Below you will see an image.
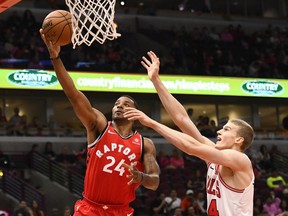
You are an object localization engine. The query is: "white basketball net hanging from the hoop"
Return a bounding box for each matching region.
[66,0,121,48]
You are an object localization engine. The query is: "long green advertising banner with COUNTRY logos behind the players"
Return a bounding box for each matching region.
[0,69,288,98]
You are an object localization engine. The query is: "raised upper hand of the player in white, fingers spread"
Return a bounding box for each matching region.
[141,51,160,80]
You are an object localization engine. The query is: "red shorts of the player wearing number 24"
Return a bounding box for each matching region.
[73,198,134,216]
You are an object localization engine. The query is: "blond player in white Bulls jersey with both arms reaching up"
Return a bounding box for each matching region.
[124,51,254,216]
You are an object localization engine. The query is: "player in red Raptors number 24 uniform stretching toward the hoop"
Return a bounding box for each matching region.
[40,29,159,216]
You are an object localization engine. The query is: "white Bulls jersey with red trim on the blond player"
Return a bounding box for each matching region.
[206,163,254,216]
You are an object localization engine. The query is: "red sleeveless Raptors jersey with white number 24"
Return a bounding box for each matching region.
[83,122,144,205]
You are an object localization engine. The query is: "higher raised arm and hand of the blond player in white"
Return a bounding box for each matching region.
[141,51,209,143]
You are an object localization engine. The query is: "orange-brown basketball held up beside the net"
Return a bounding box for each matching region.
[42,10,73,46]
